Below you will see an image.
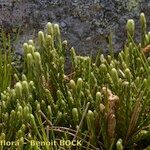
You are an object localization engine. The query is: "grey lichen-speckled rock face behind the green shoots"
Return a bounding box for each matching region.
[0,0,150,69]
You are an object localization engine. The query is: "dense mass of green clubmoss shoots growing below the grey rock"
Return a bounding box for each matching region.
[0,13,150,150]
